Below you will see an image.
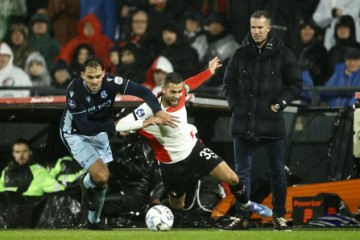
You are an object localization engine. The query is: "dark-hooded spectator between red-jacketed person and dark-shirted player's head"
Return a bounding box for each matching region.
[67,43,94,78]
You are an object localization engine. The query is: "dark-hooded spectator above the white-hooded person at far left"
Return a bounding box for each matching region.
[8,23,34,70]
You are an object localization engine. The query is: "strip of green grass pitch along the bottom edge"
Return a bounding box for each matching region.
[0,228,360,240]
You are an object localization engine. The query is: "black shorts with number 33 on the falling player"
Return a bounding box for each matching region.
[160,140,224,198]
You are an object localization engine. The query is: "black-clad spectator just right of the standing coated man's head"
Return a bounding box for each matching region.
[293,21,328,86]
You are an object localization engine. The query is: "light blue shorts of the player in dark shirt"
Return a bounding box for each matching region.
[61,132,113,170]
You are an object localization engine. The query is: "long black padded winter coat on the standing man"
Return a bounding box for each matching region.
[224,32,302,141]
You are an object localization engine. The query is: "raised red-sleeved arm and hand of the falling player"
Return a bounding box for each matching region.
[184,57,222,93]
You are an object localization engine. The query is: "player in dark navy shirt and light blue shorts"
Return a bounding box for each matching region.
[60,56,178,230]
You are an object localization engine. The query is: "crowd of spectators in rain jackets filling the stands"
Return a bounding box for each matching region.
[0,0,360,106]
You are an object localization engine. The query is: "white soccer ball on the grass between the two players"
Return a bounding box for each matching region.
[145,205,174,231]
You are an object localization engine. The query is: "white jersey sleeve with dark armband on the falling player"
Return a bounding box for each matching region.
[116,103,154,132]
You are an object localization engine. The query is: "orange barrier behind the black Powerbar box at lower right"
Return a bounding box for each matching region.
[251,179,360,222]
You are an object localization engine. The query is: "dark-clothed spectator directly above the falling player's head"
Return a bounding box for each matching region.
[160,22,199,78]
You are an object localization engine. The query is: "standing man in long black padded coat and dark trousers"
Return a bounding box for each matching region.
[224,11,302,230]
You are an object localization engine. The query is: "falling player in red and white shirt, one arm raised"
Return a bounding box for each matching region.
[116,57,272,225]
